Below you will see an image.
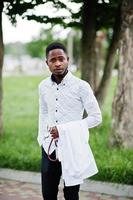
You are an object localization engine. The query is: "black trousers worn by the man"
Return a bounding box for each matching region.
[41,148,80,200]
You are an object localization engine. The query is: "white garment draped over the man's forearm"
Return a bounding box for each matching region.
[57,120,98,186]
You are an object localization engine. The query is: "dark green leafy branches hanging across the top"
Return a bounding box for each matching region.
[4,0,120,30]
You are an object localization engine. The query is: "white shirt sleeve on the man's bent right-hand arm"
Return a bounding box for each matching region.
[79,81,102,128]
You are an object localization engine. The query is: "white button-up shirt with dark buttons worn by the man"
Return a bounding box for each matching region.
[38,72,102,153]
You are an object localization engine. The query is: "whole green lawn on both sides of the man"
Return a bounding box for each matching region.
[0,74,133,184]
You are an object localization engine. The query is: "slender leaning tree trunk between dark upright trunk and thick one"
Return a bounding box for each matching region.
[95,5,120,106]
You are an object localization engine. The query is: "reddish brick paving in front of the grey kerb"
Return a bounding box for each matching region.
[0,179,133,200]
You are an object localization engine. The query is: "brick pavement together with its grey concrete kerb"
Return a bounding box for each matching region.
[0,168,133,200]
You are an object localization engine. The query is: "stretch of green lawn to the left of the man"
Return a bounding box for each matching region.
[0,77,43,171]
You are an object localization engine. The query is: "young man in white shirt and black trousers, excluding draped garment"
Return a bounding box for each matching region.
[38,42,102,200]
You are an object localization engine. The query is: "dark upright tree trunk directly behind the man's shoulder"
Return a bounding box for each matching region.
[81,0,96,90]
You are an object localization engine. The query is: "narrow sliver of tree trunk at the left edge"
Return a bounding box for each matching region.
[0,2,4,135]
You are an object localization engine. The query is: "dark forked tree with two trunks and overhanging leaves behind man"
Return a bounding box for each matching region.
[27,0,120,100]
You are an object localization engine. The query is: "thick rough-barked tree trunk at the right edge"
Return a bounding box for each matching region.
[110,0,133,148]
